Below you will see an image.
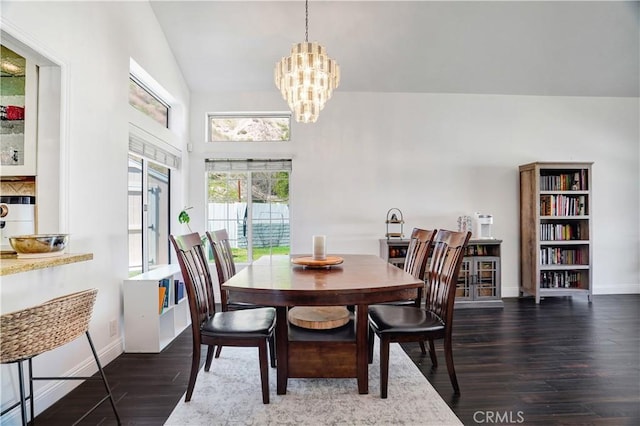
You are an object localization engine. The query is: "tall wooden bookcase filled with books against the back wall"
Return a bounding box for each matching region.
[519,162,593,303]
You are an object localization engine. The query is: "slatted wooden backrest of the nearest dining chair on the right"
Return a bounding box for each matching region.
[425,233,471,332]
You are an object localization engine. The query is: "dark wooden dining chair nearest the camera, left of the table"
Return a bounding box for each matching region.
[169,233,276,404]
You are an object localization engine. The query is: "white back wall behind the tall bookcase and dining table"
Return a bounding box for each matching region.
[190,89,640,297]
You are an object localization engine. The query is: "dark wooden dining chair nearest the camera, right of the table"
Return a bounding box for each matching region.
[369,229,471,398]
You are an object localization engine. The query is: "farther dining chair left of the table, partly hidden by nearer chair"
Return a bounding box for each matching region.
[205,229,276,368]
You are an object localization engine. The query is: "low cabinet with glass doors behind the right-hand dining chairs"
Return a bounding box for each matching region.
[379,238,503,308]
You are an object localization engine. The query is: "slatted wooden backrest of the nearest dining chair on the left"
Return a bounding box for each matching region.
[169,232,216,332]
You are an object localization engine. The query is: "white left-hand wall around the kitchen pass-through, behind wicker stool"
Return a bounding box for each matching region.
[1,1,189,424]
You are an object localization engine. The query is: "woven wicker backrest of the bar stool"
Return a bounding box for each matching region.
[0,289,98,364]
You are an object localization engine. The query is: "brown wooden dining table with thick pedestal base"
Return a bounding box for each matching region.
[222,254,424,395]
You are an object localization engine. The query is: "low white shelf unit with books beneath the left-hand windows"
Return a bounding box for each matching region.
[123,265,191,353]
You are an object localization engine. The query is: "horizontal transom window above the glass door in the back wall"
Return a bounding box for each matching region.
[207,112,291,142]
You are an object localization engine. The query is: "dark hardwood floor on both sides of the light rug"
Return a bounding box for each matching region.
[36,295,640,425]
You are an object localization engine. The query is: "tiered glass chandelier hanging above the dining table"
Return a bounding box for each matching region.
[274,0,340,123]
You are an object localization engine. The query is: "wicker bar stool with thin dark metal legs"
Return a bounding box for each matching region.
[0,289,121,425]
